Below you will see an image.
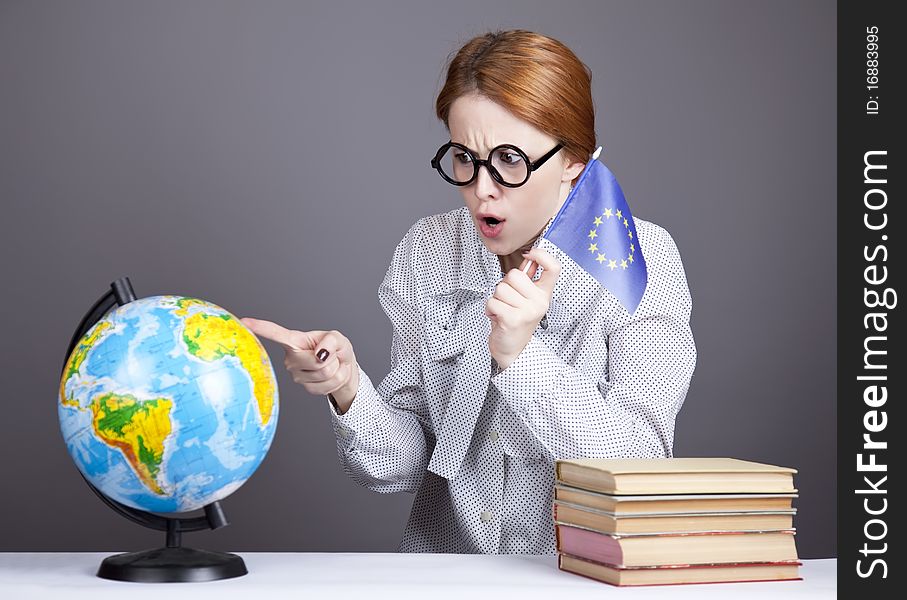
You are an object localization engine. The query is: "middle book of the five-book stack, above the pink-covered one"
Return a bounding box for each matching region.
[552,500,794,534]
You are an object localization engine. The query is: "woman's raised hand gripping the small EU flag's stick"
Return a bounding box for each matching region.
[485,248,561,369]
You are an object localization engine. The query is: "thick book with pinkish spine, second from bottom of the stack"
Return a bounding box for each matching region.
[555,523,798,567]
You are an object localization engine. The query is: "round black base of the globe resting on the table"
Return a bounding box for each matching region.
[98,547,248,583]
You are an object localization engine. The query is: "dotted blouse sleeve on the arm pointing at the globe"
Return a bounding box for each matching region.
[327,227,429,493]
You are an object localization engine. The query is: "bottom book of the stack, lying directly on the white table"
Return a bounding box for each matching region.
[558,554,803,586]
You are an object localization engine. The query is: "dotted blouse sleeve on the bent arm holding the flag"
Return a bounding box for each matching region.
[492,230,696,462]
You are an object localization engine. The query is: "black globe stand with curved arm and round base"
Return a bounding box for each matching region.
[63,277,248,583]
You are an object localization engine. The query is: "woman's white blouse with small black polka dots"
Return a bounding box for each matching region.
[326,207,696,554]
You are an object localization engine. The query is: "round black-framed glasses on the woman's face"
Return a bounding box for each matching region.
[431,142,564,188]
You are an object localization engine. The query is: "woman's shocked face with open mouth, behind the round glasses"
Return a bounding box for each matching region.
[447,93,584,256]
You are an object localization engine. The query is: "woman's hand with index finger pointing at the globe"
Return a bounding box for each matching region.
[240,317,359,413]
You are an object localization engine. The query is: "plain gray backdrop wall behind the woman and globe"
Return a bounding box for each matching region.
[0,0,836,558]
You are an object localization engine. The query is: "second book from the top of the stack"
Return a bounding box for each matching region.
[554,483,797,515]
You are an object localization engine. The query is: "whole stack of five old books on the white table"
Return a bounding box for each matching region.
[553,458,801,586]
